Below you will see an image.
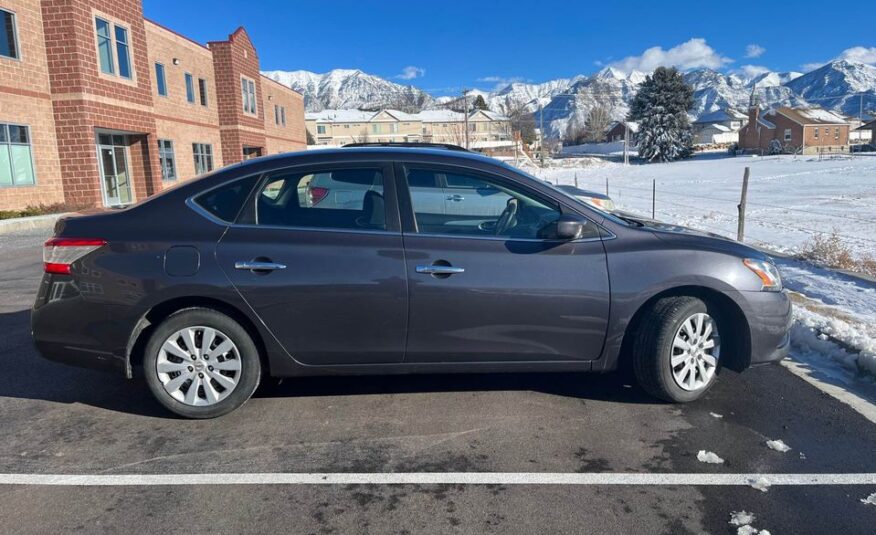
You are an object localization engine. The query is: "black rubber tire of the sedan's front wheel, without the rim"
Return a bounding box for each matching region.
[632,296,725,403]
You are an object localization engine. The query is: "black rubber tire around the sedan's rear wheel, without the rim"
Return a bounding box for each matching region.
[143,308,261,419]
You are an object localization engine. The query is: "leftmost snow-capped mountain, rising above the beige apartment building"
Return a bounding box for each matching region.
[262,69,433,111]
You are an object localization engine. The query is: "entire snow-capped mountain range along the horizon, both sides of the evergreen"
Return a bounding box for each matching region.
[263,60,876,137]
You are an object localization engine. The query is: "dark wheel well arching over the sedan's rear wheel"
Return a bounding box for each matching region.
[128,297,271,376]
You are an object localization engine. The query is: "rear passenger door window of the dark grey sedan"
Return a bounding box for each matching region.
[255,168,386,230]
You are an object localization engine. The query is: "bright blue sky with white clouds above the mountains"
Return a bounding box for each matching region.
[144,0,876,95]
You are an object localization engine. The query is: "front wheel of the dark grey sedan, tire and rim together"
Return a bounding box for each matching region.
[633,296,721,403]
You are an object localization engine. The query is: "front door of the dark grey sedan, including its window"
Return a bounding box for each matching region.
[399,164,609,362]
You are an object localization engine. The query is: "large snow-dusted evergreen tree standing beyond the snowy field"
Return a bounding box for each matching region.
[629,67,693,162]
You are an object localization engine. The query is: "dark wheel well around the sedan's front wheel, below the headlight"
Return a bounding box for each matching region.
[618,286,751,373]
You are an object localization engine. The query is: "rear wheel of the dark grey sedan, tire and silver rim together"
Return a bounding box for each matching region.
[143,308,261,418]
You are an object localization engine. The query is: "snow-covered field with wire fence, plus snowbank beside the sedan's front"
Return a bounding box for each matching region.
[526,154,876,402]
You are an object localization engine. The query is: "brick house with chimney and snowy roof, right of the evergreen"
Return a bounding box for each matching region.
[739,101,849,154]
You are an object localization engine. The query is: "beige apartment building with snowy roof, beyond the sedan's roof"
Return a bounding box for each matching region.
[305,110,514,149]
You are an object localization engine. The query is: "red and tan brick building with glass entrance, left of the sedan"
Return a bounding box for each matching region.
[0,0,306,209]
